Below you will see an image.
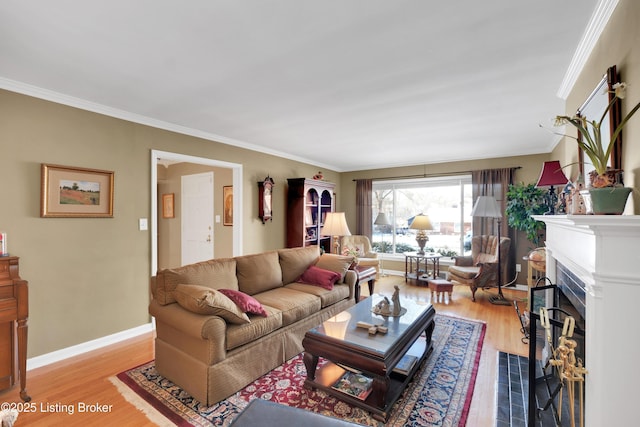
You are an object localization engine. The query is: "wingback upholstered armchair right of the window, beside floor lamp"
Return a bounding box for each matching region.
[448,235,511,301]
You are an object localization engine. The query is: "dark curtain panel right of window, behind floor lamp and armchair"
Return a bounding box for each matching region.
[471,168,516,284]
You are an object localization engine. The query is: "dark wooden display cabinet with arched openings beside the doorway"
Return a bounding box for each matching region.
[287,178,335,252]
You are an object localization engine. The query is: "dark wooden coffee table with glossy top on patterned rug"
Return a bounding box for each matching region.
[302,295,436,422]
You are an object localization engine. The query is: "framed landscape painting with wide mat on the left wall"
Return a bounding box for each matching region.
[40,163,113,218]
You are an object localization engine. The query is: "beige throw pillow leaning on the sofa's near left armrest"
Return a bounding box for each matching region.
[173,284,250,324]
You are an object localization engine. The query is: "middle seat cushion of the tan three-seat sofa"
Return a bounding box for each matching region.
[254,287,322,326]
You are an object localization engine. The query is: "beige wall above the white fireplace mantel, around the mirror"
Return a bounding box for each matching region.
[552,0,640,215]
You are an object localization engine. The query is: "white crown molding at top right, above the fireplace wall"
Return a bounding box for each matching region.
[557,0,619,100]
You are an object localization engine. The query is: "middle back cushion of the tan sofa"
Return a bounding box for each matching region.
[236,251,282,295]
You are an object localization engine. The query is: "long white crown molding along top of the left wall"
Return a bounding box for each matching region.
[0,77,343,172]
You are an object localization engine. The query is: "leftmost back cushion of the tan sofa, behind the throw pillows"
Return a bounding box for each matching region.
[154,258,238,305]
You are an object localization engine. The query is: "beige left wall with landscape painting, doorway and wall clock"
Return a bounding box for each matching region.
[0,90,339,357]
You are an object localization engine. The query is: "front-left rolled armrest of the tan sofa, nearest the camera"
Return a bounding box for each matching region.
[149,300,227,343]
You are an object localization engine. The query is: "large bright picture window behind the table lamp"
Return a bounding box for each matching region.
[371,175,473,256]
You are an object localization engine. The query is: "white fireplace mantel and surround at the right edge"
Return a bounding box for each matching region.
[534,215,640,426]
